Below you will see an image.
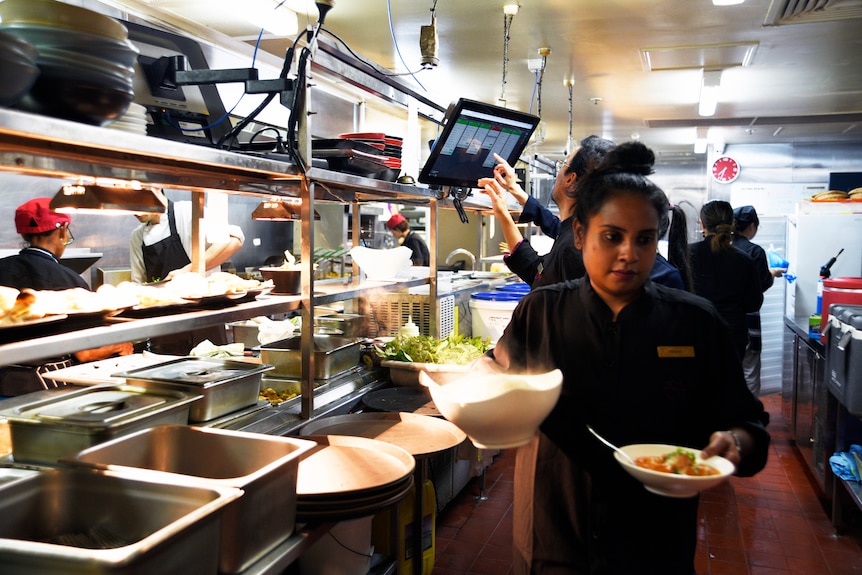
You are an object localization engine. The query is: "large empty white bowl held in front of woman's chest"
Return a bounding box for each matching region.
[419,369,563,449]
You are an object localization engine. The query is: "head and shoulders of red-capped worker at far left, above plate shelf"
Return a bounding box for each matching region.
[0,198,89,290]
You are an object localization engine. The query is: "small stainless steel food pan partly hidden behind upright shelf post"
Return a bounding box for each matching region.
[260,335,359,379]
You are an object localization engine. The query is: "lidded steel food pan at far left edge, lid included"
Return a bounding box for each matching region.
[0,384,200,464]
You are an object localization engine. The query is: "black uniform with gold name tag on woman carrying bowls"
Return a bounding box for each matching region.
[493,277,769,575]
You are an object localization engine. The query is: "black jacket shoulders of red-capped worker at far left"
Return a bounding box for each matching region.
[0,247,90,290]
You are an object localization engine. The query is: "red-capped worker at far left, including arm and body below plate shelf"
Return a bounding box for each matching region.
[0,198,133,397]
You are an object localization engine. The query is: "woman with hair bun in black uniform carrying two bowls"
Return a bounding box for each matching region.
[484,142,769,575]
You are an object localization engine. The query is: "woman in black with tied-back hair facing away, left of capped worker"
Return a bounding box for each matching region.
[690,200,763,359]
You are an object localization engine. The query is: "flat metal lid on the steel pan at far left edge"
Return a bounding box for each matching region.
[0,384,201,428]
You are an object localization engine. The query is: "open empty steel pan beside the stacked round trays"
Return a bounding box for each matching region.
[62,425,316,573]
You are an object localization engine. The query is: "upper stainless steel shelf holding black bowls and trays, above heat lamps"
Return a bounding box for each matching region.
[0,109,435,202]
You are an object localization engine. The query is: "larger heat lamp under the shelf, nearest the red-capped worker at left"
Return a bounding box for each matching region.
[49,178,167,215]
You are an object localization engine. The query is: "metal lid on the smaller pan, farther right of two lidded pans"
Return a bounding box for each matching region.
[111,357,273,387]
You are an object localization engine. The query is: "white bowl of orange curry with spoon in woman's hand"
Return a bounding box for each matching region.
[614,443,736,497]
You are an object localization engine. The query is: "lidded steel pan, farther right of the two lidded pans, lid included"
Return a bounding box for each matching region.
[111,357,272,422]
